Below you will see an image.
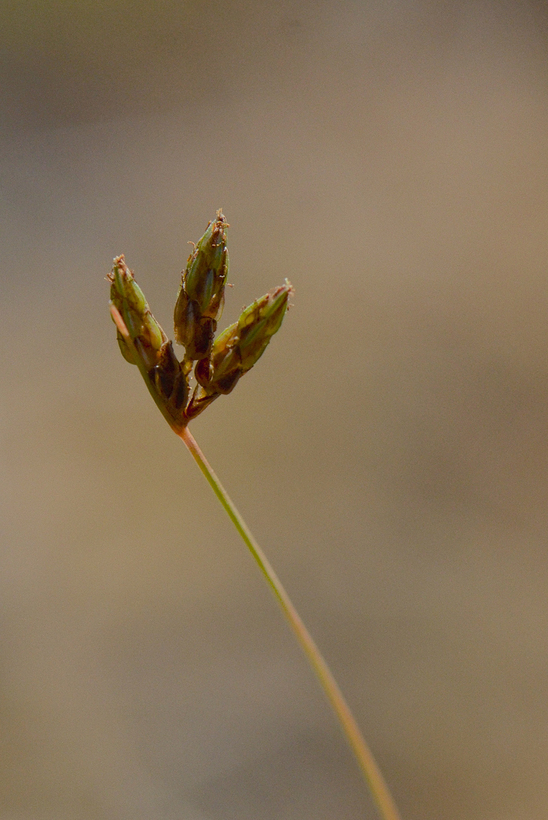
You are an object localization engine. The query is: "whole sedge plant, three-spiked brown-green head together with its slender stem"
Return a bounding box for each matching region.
[107,211,400,820]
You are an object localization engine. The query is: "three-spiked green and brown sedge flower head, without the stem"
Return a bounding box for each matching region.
[107,211,293,430]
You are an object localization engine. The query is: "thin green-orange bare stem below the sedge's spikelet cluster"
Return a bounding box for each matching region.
[180,427,401,820]
